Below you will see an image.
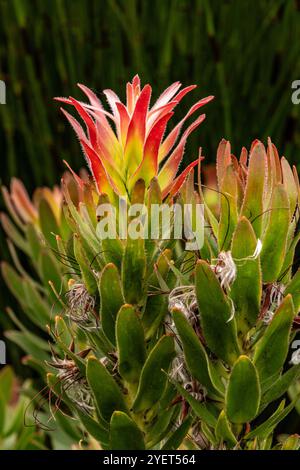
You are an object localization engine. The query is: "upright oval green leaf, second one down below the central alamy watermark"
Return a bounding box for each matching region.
[116,305,146,383]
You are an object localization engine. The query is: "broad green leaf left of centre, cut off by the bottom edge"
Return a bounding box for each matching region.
[110,411,145,450]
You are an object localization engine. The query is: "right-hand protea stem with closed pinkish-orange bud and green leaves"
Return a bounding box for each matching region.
[169,139,300,449]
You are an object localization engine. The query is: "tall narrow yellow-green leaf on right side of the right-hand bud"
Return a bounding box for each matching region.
[260,184,290,282]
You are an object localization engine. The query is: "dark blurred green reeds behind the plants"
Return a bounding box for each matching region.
[0,0,300,195]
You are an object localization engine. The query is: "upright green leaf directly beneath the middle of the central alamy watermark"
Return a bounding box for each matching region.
[122,237,146,304]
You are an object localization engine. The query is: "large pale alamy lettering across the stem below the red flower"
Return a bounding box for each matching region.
[97,197,205,251]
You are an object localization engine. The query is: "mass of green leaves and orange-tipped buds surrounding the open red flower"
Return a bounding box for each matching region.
[0,67,299,450]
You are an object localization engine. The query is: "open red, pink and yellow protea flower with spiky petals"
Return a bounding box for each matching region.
[56,75,213,198]
